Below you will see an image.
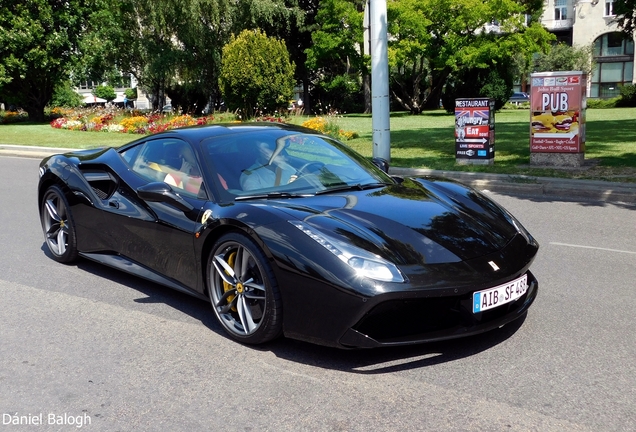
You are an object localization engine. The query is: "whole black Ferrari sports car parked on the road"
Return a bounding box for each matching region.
[38,123,539,348]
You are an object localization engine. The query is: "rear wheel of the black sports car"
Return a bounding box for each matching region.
[40,186,77,263]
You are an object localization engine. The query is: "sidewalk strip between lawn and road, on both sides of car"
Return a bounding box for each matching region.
[0,144,636,204]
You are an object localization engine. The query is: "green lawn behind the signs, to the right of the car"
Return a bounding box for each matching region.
[330,108,636,181]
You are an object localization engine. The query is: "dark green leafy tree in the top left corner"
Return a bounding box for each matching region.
[0,0,97,121]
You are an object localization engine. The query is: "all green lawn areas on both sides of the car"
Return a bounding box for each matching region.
[0,108,636,181]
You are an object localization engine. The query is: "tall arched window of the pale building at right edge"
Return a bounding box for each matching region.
[590,32,634,98]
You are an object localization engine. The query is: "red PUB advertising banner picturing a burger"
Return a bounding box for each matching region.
[530,72,587,153]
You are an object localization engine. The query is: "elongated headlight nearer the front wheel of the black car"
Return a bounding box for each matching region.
[289,221,404,282]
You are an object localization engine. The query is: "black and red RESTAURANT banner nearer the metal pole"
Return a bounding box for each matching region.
[455,98,495,164]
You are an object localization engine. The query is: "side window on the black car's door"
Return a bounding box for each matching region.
[128,138,206,198]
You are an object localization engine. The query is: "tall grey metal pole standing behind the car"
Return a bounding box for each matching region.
[368,0,391,161]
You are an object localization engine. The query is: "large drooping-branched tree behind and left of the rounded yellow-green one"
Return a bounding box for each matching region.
[91,0,303,113]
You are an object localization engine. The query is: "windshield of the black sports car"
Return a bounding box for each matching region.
[202,129,393,199]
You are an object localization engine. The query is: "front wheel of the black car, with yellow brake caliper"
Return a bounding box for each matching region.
[207,233,282,344]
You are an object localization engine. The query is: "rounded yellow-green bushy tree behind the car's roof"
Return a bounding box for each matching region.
[219,30,295,118]
